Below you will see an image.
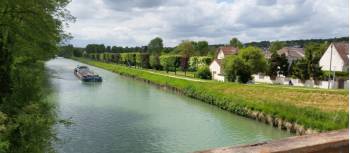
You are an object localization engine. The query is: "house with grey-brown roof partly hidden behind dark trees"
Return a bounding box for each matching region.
[277,47,305,66]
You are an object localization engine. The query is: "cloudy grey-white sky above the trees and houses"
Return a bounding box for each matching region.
[66,0,349,47]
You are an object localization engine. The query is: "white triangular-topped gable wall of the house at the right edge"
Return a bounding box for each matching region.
[319,44,346,71]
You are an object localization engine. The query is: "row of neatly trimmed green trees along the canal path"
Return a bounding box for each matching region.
[84,53,212,79]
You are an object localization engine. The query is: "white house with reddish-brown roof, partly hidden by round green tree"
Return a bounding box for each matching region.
[209,46,239,81]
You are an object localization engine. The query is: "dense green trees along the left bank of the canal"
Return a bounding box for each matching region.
[0,0,74,153]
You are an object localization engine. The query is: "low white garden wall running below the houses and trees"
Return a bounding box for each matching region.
[253,74,349,89]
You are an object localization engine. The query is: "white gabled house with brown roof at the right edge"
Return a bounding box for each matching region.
[319,42,349,71]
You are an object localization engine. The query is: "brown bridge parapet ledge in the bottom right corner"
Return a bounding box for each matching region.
[196,129,349,153]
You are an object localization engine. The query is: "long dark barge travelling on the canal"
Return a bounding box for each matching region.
[74,66,102,82]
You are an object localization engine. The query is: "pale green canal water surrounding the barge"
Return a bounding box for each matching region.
[46,58,290,153]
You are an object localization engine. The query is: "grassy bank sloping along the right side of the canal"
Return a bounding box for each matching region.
[75,58,348,131]
